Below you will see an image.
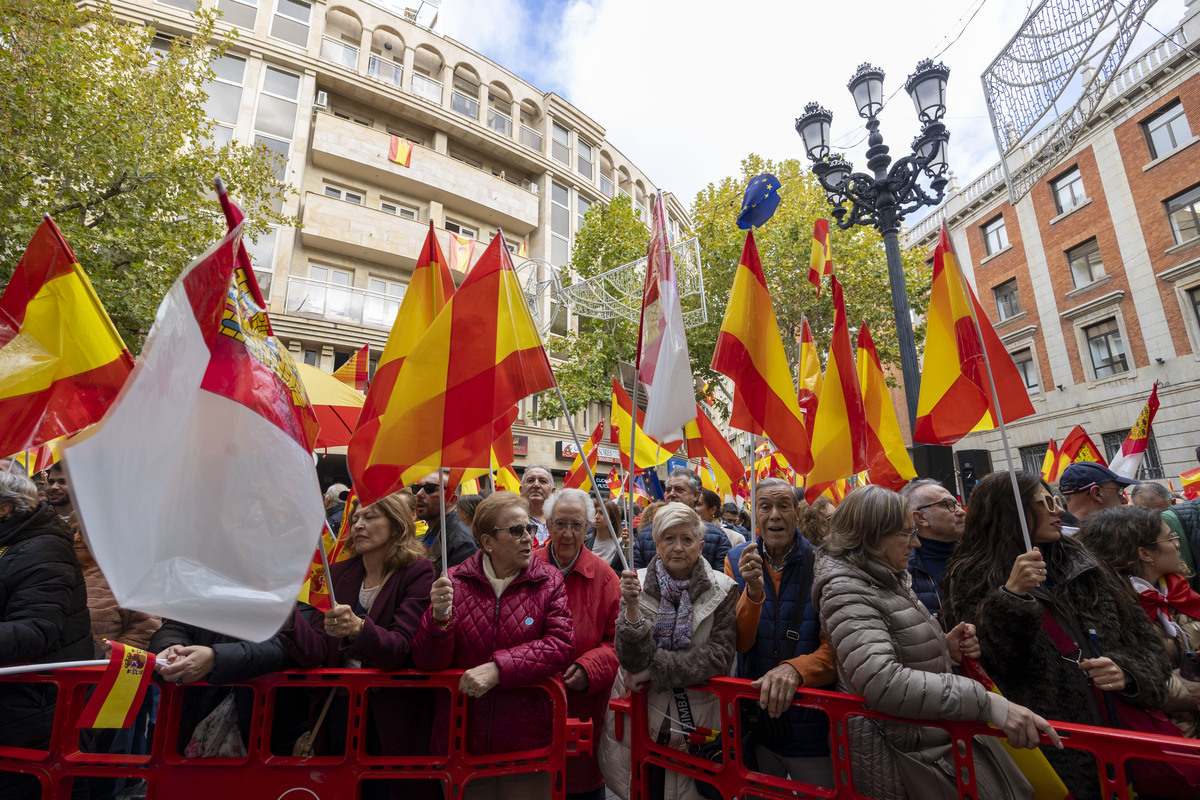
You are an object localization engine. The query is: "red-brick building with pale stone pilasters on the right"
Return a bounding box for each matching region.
[906,4,1200,488]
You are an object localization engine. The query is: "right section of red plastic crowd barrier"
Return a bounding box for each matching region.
[611,678,1200,800]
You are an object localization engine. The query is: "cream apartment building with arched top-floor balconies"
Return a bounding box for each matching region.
[120,0,690,479]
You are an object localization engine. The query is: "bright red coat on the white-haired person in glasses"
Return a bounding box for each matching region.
[534,545,620,793]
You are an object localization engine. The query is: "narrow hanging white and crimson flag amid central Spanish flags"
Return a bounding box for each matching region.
[637,192,696,441]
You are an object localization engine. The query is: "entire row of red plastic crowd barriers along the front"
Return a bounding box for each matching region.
[7,667,1200,800]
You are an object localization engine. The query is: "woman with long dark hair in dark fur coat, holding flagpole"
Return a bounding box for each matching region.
[942,471,1171,800]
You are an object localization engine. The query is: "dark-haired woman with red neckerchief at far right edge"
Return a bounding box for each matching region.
[1075,506,1200,739]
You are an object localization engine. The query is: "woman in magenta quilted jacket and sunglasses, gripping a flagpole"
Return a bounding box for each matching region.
[413,492,575,800]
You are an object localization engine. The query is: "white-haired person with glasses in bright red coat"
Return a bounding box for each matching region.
[533,489,620,800]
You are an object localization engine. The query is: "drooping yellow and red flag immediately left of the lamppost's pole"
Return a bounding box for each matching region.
[858,323,917,492]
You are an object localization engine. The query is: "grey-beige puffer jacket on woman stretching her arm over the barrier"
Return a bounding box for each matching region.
[812,553,1008,800]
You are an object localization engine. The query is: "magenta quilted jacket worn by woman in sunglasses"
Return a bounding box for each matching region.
[413,552,575,754]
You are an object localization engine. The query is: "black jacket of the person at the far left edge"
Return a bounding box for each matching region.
[0,503,96,747]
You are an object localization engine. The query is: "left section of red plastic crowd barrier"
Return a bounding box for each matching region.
[0,667,592,800]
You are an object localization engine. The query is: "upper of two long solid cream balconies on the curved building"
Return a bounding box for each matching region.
[305,112,538,232]
